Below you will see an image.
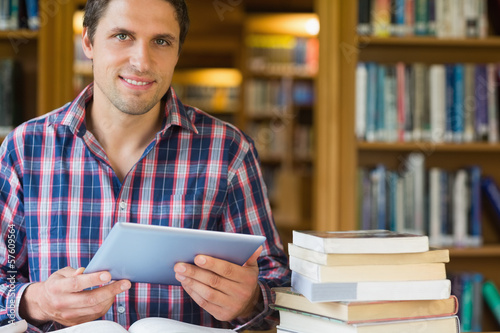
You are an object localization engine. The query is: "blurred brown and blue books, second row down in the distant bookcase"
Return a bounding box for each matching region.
[245,77,314,117]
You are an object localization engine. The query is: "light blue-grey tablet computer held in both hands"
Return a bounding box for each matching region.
[84,222,265,285]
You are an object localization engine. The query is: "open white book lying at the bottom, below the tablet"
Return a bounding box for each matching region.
[56,318,235,333]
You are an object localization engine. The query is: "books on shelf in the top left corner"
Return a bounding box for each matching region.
[0,0,40,30]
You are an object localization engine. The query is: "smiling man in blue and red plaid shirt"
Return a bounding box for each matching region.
[0,0,289,331]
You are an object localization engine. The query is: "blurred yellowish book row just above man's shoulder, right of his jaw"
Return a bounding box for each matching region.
[172,83,240,113]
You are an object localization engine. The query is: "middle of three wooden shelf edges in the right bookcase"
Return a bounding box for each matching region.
[357,142,500,153]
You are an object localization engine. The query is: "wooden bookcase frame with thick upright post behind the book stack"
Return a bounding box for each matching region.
[313,0,500,331]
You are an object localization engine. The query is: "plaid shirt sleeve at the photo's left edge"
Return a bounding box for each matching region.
[0,136,29,326]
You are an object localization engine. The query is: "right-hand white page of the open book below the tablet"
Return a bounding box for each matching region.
[129,318,235,333]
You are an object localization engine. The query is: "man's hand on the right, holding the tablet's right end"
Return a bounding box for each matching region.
[174,246,262,321]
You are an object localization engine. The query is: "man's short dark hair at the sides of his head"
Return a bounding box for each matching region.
[83,0,189,53]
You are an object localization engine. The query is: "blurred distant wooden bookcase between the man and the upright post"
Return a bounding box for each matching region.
[241,13,317,243]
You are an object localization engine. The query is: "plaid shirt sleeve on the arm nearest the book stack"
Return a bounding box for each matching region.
[225,136,290,330]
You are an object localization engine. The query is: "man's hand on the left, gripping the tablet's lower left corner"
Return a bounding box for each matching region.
[19,267,131,326]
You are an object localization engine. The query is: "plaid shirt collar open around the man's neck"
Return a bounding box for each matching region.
[51,83,198,136]
